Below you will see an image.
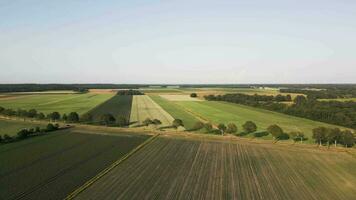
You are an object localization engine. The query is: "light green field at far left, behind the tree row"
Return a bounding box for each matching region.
[0,93,113,114]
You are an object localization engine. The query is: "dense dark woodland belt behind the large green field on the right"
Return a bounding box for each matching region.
[205,94,356,128]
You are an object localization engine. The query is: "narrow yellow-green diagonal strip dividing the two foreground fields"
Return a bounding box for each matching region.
[65,133,160,200]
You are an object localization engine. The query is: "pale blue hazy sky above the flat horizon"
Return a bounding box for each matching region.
[0,0,356,84]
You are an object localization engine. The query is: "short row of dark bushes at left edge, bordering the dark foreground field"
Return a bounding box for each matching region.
[0,123,59,143]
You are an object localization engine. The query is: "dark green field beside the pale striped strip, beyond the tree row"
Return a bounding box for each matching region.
[89,95,132,120]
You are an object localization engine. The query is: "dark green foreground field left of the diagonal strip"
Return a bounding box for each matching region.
[0,130,148,200]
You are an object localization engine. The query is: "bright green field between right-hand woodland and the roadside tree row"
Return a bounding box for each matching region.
[177,101,348,142]
